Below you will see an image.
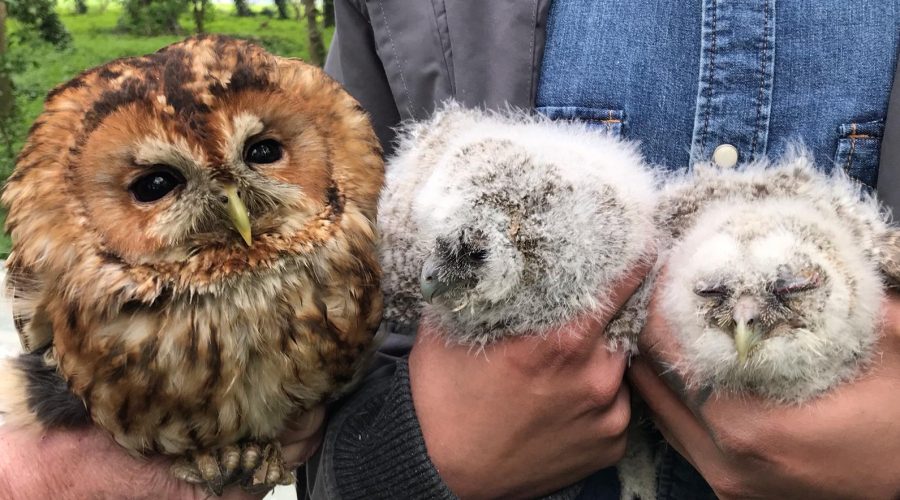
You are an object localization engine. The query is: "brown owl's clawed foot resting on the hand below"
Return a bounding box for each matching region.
[171,441,294,495]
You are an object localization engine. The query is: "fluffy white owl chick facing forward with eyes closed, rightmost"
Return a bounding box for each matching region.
[659,152,900,403]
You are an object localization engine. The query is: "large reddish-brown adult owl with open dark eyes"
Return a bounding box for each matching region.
[0,37,383,493]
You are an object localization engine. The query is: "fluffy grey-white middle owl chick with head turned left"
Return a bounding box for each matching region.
[379,105,656,346]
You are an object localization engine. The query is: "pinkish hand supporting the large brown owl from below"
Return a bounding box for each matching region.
[0,407,325,500]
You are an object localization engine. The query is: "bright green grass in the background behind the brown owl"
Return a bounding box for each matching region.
[0,2,334,256]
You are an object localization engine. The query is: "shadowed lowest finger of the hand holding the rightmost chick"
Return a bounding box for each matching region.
[627,359,719,463]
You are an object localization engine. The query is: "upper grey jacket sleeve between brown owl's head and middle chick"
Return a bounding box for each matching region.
[325,0,400,155]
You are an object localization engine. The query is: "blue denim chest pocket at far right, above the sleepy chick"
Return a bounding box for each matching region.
[834,120,884,188]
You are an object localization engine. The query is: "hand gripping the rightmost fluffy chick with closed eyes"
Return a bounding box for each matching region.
[628,286,900,498]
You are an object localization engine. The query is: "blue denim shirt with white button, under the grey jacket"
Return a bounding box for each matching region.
[536,0,900,186]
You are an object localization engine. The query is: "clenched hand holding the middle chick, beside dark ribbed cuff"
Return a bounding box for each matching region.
[409,268,647,498]
